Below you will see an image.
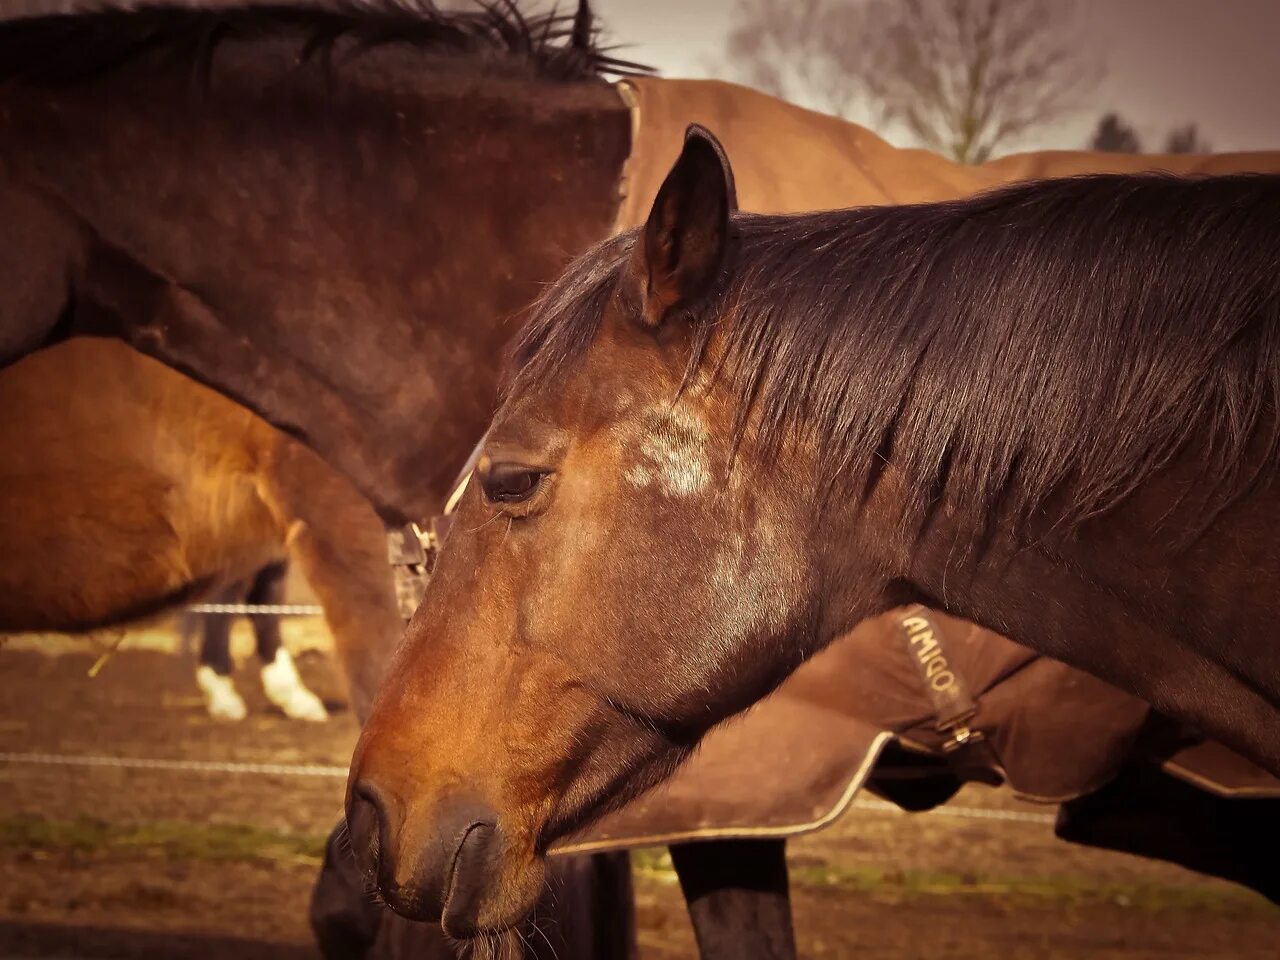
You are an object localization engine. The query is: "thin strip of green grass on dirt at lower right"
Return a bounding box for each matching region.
[631,847,1275,914]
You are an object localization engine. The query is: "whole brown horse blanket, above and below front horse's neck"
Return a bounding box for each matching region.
[559,79,1280,851]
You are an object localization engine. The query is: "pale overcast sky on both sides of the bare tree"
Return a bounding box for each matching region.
[593,0,1280,151]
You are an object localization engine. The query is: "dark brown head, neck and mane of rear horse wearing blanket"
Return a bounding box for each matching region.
[0,3,630,521]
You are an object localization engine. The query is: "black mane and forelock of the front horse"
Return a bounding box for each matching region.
[515,174,1280,527]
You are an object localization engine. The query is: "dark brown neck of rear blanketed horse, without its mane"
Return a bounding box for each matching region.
[0,58,628,521]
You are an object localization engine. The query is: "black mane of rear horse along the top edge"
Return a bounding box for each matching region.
[0,0,646,83]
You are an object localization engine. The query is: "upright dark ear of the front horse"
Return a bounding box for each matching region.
[625,123,737,328]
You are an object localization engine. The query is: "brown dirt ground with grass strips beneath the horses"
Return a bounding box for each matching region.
[0,625,1280,960]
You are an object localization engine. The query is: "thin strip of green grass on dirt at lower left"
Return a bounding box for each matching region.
[0,814,326,863]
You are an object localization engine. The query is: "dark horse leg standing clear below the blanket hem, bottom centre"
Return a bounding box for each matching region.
[671,840,796,960]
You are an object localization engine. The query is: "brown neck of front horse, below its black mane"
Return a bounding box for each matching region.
[822,448,1280,772]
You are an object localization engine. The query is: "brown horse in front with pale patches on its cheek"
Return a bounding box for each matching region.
[348,128,1280,934]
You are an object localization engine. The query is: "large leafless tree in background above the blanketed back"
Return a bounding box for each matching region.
[727,0,1096,163]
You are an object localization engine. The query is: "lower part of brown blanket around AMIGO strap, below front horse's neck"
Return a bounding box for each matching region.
[559,611,1280,851]
